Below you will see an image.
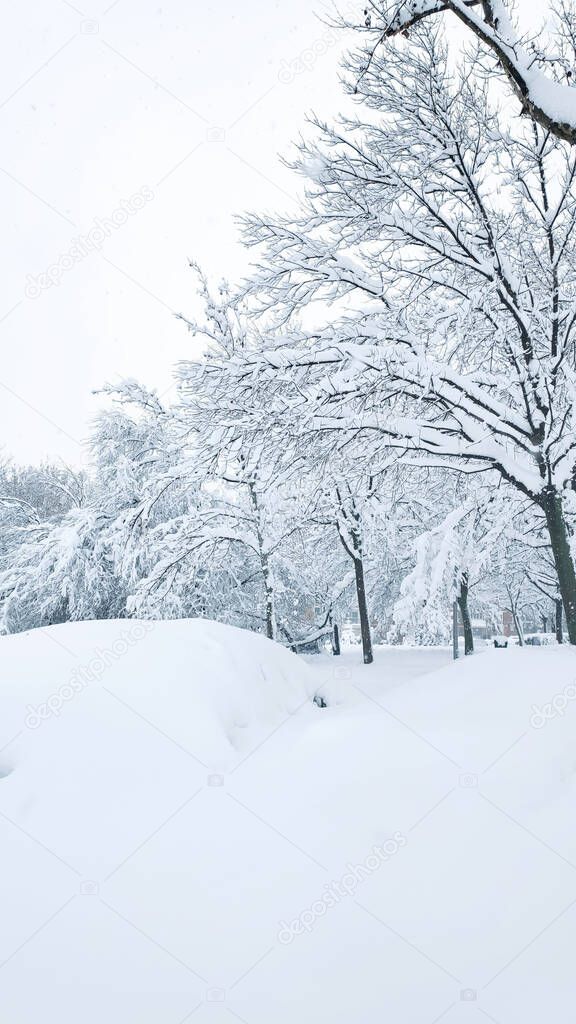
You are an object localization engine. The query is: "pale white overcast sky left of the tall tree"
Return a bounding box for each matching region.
[0,0,344,464]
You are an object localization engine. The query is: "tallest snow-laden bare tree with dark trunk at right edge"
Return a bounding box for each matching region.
[219,22,576,643]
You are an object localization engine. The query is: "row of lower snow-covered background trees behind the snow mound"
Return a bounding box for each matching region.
[0,446,563,664]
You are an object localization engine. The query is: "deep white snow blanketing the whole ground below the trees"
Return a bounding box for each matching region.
[0,622,576,1024]
